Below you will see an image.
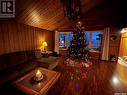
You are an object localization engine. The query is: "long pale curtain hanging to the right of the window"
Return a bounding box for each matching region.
[101,27,110,60]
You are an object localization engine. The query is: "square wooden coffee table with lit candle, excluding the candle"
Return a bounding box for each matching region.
[12,68,60,95]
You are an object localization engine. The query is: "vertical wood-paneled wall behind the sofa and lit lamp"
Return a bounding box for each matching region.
[0,21,54,54]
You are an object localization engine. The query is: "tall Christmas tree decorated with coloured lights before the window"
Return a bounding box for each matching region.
[68,22,89,63]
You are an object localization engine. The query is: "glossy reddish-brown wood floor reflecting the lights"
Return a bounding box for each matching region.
[48,60,127,95]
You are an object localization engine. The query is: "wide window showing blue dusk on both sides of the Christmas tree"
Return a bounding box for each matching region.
[58,31,103,50]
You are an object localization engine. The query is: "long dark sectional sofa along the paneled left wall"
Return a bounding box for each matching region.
[0,50,58,87]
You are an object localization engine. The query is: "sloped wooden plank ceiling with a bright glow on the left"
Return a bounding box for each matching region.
[15,0,126,31]
